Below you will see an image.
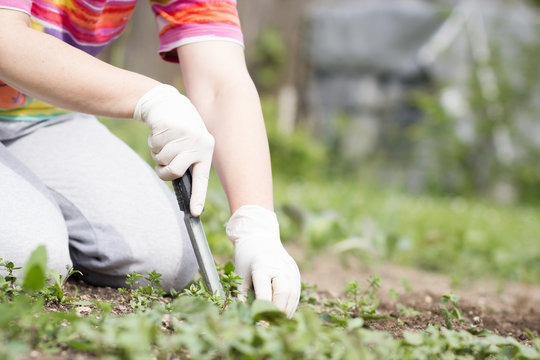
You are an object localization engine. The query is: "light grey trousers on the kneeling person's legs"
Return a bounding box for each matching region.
[0,113,197,290]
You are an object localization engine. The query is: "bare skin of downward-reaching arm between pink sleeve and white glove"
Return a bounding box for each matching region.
[178,41,273,213]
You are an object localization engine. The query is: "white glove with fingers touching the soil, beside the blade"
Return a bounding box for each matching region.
[226,205,301,317]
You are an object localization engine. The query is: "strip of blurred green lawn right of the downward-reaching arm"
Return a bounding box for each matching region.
[276,177,540,283]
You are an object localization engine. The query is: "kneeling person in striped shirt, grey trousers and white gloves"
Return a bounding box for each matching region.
[0,0,300,316]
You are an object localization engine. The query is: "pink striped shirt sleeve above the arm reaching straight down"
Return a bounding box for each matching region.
[146,0,244,62]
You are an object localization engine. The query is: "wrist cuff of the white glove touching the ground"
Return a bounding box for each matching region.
[225,205,281,245]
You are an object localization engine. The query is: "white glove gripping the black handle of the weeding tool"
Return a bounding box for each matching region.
[133,84,214,216]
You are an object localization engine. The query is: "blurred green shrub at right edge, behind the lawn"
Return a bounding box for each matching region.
[411,25,540,201]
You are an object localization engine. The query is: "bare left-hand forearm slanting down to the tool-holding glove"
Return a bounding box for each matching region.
[0,9,159,118]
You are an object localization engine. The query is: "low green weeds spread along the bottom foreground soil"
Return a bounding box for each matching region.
[0,250,540,360]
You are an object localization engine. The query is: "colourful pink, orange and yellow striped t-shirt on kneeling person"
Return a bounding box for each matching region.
[0,0,243,121]
